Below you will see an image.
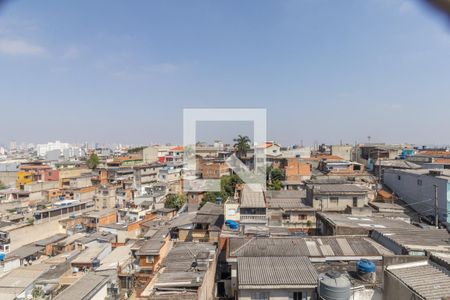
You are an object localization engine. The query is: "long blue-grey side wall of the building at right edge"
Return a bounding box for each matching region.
[384,169,450,222]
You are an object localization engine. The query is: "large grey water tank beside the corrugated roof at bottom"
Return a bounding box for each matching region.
[318,271,351,300]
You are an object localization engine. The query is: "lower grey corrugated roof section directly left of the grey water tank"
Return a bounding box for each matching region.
[237,256,318,290]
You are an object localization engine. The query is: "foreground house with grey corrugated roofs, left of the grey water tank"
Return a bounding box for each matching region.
[222,236,392,300]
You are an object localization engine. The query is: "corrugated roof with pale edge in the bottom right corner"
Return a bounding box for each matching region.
[387,261,450,300]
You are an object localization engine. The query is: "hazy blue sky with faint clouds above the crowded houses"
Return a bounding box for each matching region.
[0,0,450,144]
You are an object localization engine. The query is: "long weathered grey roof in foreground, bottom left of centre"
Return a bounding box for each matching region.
[139,242,217,300]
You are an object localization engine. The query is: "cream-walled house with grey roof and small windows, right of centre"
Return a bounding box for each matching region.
[306,183,369,211]
